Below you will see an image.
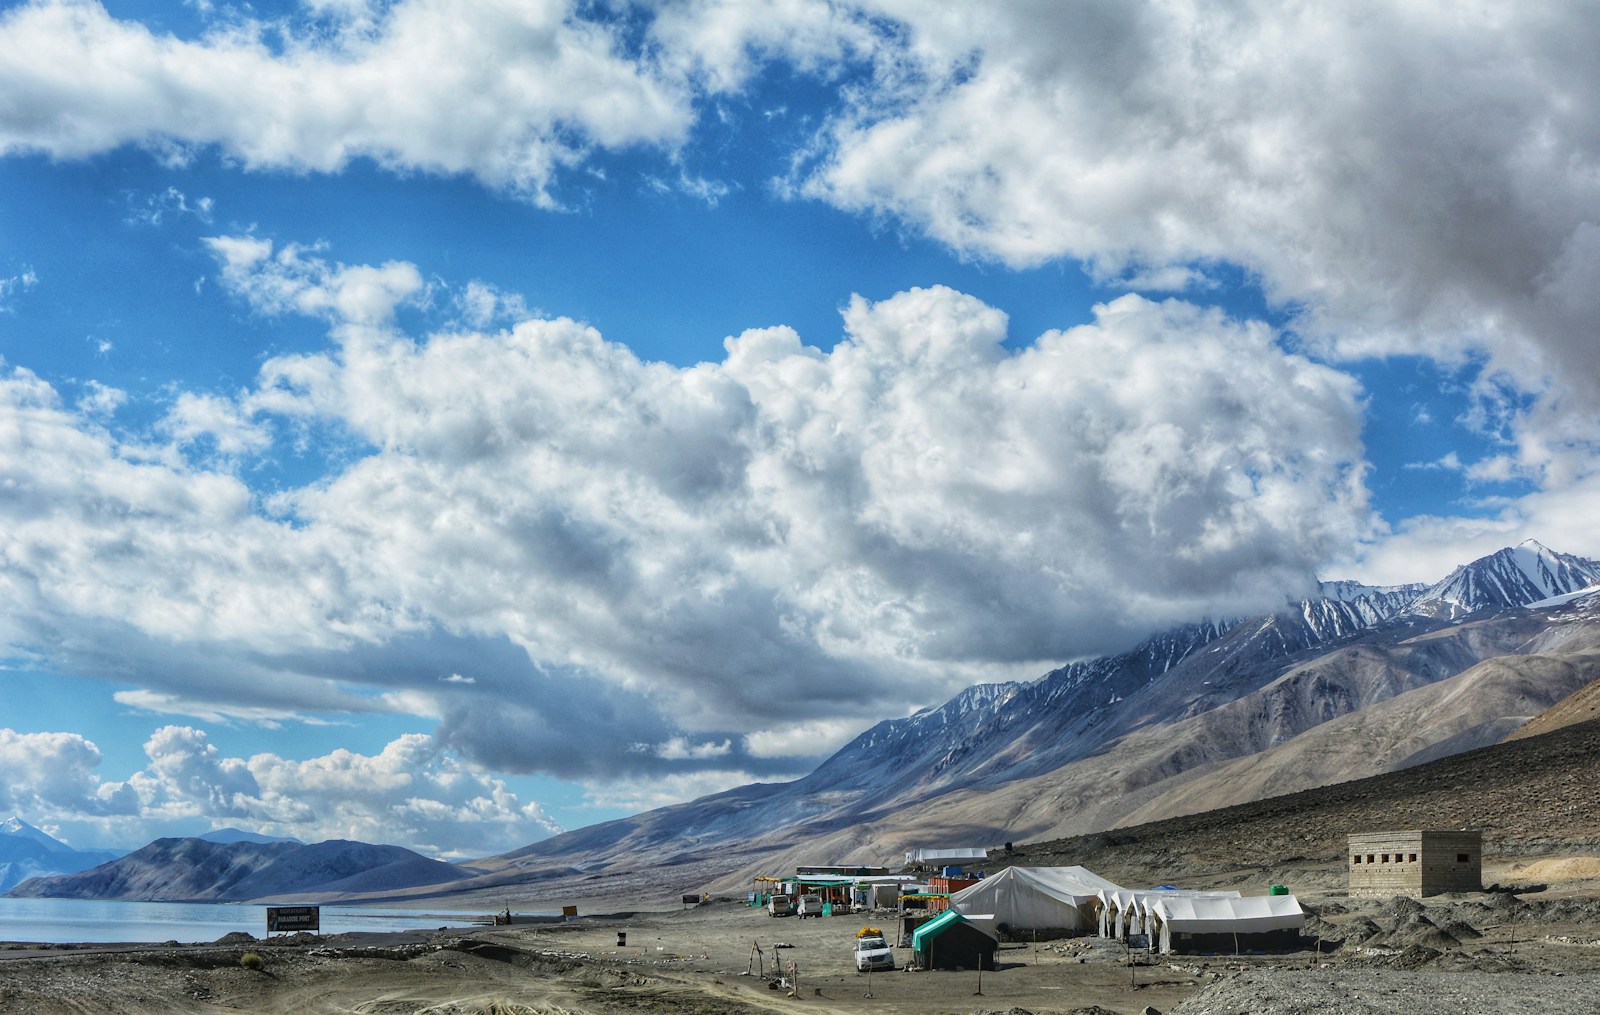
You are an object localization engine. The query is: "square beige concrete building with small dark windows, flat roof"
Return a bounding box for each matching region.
[1346,831,1483,898]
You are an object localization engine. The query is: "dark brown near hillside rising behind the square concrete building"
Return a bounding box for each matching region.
[990,707,1600,884]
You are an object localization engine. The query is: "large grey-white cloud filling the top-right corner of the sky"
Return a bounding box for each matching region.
[793,0,1600,387]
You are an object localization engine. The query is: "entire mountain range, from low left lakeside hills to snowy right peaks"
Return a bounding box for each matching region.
[14,541,1600,900]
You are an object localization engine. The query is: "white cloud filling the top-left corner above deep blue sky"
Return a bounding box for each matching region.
[0,0,691,205]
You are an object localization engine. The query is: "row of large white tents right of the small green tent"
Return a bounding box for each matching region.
[950,866,1306,953]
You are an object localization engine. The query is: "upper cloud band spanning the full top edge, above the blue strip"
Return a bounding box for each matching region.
[9,0,1600,419]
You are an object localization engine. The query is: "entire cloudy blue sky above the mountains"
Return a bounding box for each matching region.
[0,0,1600,857]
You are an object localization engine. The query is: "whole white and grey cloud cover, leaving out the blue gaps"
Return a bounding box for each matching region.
[0,0,1600,828]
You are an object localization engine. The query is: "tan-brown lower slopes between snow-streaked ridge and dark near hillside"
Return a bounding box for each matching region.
[717,633,1600,889]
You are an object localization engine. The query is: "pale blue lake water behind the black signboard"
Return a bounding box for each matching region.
[0,898,486,945]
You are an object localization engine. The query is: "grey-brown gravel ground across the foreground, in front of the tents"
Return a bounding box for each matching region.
[9,857,1600,1015]
